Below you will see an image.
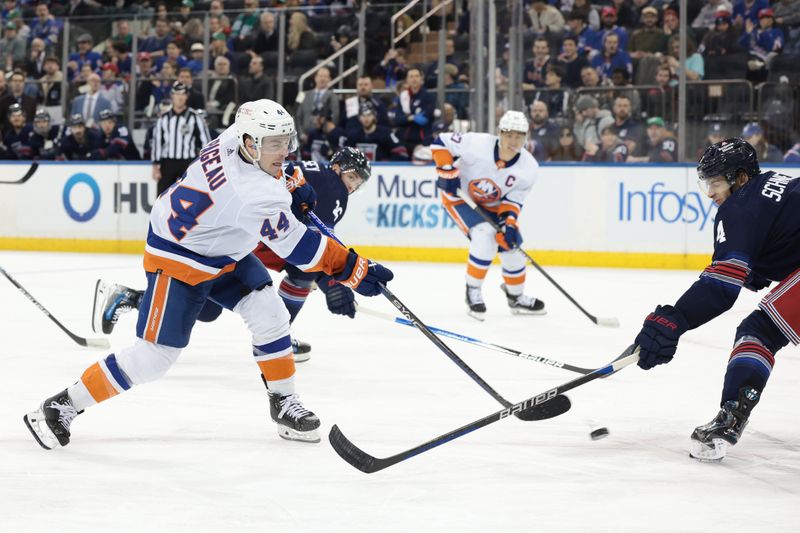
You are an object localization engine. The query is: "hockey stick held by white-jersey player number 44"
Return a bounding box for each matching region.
[306,210,572,421]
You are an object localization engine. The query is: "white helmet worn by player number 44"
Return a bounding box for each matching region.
[239,98,297,161]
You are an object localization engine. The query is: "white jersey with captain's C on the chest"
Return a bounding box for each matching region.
[431,133,539,216]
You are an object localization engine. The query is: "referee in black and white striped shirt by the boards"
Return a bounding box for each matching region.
[152,81,211,194]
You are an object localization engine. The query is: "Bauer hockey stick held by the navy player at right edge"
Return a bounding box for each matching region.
[328,345,639,474]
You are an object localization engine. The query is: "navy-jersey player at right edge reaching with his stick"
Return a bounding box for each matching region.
[635,138,800,461]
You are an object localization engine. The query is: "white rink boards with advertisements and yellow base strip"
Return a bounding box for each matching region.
[0,162,800,268]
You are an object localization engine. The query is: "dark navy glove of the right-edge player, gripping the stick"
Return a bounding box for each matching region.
[634,305,689,370]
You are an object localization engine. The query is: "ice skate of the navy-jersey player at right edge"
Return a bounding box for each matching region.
[689,387,760,463]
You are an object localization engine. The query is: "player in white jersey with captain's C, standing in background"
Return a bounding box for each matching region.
[431,111,546,320]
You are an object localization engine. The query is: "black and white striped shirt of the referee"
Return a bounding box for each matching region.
[152,108,211,162]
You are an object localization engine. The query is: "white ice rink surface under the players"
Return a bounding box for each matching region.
[0,252,800,532]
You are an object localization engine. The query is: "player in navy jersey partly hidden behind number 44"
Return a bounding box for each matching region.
[92,148,370,363]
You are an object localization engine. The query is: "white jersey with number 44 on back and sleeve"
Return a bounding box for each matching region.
[144,126,347,285]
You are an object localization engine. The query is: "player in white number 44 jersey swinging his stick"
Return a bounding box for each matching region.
[24,100,393,449]
